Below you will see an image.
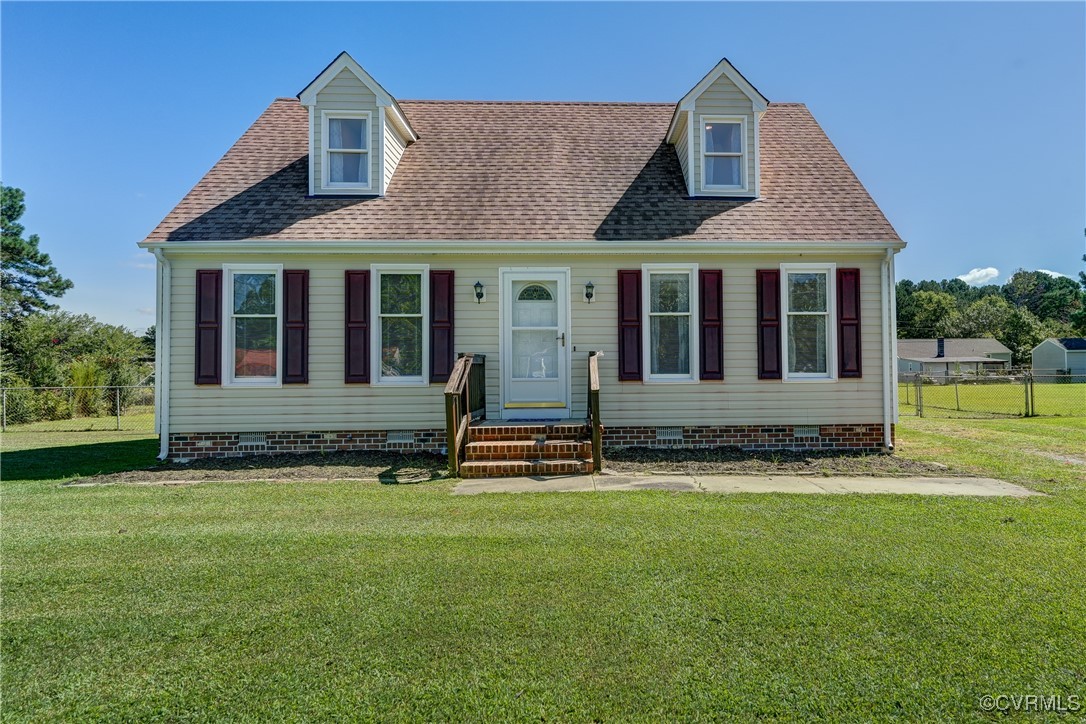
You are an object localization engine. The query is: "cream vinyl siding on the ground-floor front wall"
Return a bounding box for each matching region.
[167,252,882,433]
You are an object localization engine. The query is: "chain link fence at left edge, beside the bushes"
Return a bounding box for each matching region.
[0,385,154,433]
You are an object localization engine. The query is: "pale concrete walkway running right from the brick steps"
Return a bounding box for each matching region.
[453,475,1044,498]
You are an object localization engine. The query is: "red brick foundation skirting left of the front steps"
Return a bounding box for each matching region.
[169,430,445,460]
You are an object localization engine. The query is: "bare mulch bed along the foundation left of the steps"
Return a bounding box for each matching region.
[73,452,447,485]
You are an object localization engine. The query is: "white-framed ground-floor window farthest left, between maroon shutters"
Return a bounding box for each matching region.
[223,264,282,386]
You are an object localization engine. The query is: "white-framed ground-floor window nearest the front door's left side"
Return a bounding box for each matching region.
[371,265,430,384]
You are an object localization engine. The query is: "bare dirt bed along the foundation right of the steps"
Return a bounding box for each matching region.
[604,447,962,477]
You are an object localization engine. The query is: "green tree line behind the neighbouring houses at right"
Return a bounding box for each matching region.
[897,264,1086,366]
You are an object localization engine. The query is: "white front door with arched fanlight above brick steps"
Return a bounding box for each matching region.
[498,269,570,420]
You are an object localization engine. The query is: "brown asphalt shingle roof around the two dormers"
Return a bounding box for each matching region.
[148,99,899,241]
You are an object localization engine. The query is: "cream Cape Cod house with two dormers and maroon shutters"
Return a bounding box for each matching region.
[140,53,905,474]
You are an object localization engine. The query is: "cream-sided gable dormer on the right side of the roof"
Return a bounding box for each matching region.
[667,58,769,198]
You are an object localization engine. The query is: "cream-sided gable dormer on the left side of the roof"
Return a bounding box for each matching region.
[298,52,418,196]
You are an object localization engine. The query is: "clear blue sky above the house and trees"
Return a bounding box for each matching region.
[0,1,1086,329]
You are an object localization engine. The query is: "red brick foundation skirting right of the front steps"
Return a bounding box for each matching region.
[604,423,896,450]
